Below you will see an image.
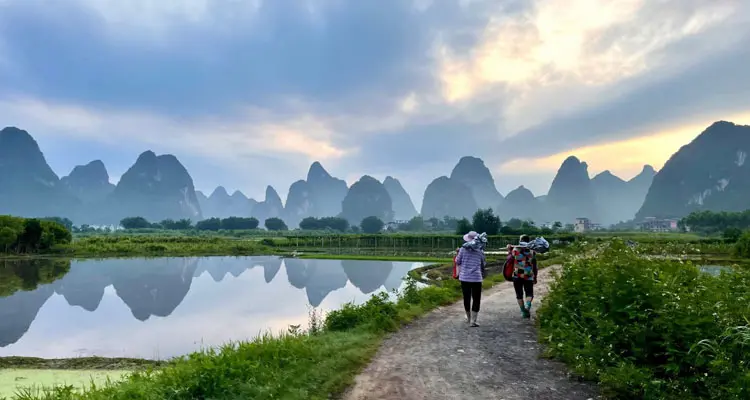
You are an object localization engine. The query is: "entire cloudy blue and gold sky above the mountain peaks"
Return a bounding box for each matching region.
[0,0,750,205]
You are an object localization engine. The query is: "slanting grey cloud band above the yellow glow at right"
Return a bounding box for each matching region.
[508,29,750,156]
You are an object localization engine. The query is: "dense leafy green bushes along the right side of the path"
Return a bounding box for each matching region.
[538,241,750,399]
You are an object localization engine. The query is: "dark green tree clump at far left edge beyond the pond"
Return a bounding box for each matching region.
[0,215,73,254]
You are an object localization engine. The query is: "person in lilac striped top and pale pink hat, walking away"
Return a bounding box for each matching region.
[456,231,487,327]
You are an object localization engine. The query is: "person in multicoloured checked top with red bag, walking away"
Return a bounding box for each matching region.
[508,235,546,318]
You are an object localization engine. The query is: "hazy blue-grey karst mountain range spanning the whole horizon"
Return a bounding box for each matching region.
[5,121,750,227]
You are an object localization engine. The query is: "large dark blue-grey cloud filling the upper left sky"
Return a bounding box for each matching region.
[0,0,528,120]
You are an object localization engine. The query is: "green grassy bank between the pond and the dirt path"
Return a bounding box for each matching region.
[4,268,506,400]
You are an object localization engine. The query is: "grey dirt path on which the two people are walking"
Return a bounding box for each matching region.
[344,267,597,400]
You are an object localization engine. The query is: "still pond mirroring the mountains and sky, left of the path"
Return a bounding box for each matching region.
[0,257,423,359]
